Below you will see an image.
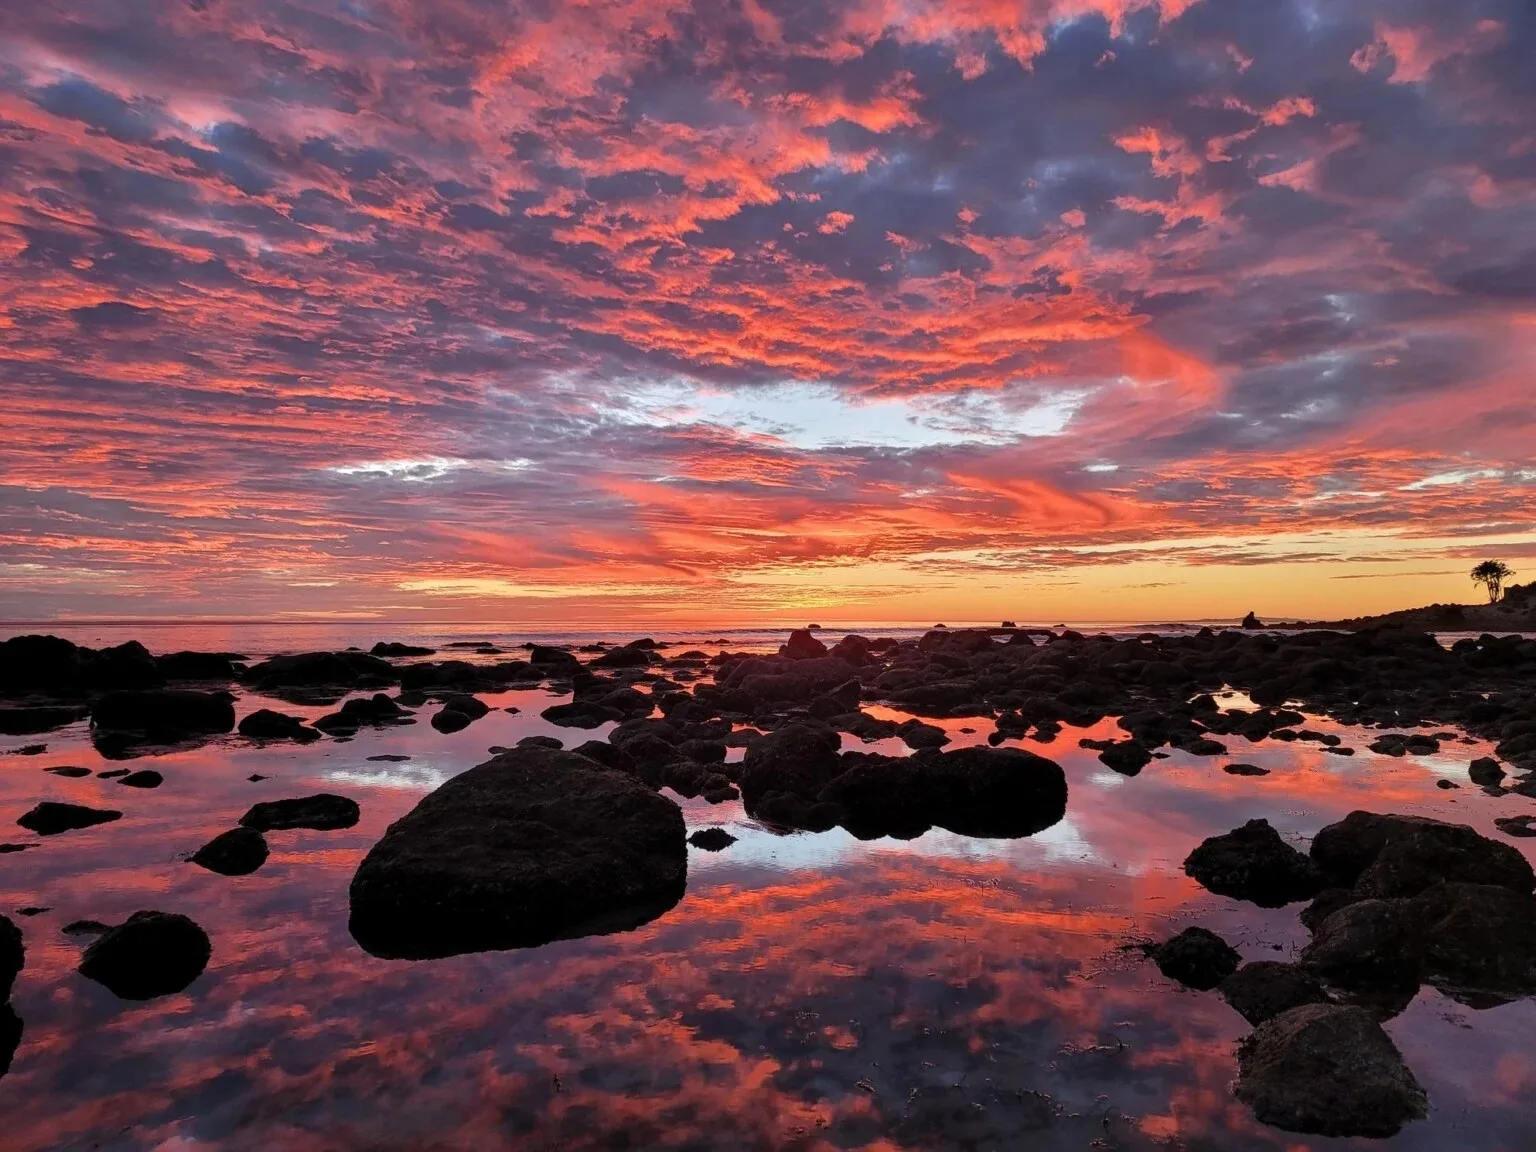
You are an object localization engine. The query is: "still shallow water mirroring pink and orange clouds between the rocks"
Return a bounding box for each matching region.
[0,634,1536,1152]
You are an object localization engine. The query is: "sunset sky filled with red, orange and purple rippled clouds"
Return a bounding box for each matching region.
[0,0,1536,624]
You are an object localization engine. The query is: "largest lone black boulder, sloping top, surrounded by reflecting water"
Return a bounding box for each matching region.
[350,748,688,960]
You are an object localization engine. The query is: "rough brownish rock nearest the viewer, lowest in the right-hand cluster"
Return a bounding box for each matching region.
[1236,1005,1428,1137]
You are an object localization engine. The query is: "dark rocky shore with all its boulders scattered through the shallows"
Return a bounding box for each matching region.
[0,621,1536,1135]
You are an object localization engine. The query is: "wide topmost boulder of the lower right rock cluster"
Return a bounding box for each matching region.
[1312,811,1536,897]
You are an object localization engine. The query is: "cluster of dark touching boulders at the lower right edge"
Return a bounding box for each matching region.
[1146,811,1536,1137]
